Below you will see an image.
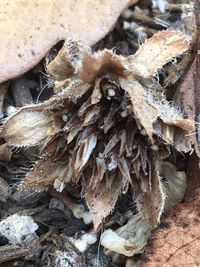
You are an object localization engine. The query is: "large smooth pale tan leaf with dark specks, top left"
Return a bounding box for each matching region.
[0,0,131,82]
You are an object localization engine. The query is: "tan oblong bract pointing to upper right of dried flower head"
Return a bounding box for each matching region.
[130,31,190,78]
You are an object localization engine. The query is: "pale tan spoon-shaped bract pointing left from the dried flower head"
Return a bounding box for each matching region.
[2,80,90,147]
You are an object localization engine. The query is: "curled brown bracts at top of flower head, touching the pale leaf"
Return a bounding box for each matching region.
[47,40,131,83]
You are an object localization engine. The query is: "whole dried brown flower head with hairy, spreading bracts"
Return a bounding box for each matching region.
[3,30,195,256]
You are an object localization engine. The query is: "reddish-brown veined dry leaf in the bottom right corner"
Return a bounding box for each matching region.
[141,190,200,267]
